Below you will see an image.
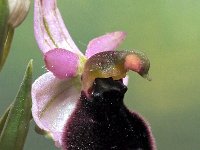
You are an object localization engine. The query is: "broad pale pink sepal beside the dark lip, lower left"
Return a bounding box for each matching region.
[32,72,81,146]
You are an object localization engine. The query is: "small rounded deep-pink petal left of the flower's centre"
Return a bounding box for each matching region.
[44,48,79,79]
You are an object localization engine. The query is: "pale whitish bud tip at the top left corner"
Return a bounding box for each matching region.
[8,0,30,27]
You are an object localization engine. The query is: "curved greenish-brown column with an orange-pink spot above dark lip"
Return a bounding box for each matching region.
[82,51,150,94]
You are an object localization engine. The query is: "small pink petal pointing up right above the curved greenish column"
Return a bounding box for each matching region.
[85,31,126,58]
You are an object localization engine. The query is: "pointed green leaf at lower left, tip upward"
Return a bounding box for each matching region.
[0,61,32,150]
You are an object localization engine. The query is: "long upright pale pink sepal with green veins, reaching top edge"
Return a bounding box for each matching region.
[34,0,82,55]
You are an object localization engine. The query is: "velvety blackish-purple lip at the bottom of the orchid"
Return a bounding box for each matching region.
[63,78,156,150]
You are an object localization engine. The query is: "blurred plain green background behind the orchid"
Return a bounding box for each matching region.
[0,0,200,150]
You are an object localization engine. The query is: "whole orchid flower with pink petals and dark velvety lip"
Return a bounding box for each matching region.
[32,0,155,150]
